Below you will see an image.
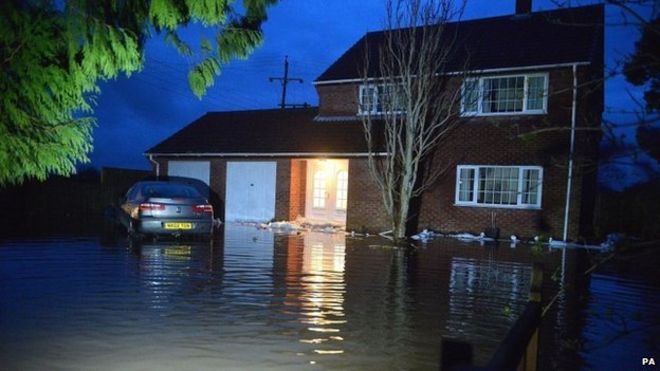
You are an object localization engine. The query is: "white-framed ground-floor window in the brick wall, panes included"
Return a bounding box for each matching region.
[456,165,543,208]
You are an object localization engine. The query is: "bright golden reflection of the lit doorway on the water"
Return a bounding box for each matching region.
[274,232,346,363]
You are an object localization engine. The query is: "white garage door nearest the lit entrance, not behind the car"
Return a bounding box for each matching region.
[225,162,277,222]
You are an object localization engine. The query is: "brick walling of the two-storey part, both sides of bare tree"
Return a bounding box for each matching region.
[316,67,602,239]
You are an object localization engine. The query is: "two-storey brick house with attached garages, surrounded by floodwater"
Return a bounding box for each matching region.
[145,1,604,239]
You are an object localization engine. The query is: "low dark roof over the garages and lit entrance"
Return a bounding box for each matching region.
[146,107,378,156]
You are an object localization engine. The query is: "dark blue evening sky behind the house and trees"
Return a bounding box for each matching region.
[91,0,656,190]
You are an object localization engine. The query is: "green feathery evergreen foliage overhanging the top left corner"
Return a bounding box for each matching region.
[0,0,276,186]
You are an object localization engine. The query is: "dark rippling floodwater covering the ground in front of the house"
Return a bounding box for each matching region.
[0,225,660,370]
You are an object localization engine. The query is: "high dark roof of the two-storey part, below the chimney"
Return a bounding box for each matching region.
[316,4,604,82]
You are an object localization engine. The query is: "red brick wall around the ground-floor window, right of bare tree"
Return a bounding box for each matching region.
[419,69,598,239]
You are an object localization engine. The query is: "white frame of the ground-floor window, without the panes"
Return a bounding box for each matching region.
[454,165,543,209]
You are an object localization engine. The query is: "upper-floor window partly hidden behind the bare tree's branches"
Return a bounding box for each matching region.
[359,84,404,114]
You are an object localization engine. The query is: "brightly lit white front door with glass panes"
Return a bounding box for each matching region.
[305,160,348,225]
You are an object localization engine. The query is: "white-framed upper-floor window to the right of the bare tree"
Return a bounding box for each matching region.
[461,74,548,115]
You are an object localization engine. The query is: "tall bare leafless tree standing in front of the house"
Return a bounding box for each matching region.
[360,0,464,240]
